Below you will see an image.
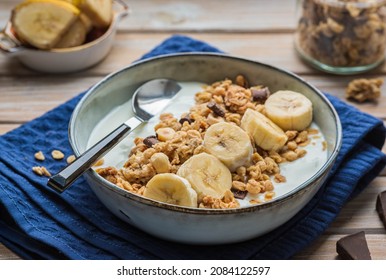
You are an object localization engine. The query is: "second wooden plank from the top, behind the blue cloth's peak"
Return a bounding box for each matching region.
[0,32,386,76]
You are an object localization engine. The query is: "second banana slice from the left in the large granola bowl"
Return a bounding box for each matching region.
[177,153,232,200]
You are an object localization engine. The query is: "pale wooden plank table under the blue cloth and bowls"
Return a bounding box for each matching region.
[0,0,386,259]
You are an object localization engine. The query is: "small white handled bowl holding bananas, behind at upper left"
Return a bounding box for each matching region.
[0,0,129,73]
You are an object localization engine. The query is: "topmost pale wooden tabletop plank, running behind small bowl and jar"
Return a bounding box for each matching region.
[0,0,296,32]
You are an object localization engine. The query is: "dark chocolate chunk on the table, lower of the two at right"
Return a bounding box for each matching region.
[336,231,371,260]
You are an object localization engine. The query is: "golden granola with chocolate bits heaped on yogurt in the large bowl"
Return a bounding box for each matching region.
[96,75,318,209]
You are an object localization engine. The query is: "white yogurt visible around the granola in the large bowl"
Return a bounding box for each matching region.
[87,82,327,207]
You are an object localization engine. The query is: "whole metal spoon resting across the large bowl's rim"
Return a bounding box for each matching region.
[47,79,181,193]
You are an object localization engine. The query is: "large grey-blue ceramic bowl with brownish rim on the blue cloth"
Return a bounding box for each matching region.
[69,53,342,244]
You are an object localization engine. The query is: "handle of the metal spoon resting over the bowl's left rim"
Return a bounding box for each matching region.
[47,117,142,193]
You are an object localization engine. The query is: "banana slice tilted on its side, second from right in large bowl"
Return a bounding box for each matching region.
[240,109,288,151]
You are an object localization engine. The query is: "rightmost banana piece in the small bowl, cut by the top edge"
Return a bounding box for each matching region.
[79,0,113,27]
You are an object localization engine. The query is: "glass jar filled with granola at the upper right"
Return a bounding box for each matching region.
[295,0,386,74]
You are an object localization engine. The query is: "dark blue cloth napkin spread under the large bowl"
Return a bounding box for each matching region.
[0,35,386,259]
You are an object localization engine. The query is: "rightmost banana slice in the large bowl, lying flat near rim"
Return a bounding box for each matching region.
[265,90,312,131]
